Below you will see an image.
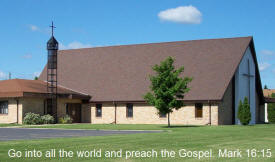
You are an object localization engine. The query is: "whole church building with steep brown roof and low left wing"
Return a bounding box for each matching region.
[0,37,272,125]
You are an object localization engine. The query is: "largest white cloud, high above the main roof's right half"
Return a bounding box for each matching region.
[158,5,202,24]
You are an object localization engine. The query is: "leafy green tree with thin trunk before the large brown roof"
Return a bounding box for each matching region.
[144,57,192,127]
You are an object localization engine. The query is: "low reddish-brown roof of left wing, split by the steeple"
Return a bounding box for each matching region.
[0,79,90,99]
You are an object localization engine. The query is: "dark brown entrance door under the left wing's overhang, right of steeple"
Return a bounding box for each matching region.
[66,103,81,123]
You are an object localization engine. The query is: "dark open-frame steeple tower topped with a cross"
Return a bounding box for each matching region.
[47,22,58,121]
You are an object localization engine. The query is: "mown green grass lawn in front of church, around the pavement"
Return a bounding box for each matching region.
[0,124,275,162]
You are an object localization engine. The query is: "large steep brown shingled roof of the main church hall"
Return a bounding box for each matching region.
[39,37,261,102]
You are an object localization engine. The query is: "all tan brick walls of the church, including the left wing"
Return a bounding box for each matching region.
[0,83,263,125]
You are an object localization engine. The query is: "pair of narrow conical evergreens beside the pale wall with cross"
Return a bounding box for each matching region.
[238,97,251,125]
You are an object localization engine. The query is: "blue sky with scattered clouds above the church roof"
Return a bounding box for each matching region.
[0,0,275,88]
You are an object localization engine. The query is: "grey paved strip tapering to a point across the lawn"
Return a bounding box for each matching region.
[0,128,161,141]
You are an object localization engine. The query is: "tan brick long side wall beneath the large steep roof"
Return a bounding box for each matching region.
[89,103,221,125]
